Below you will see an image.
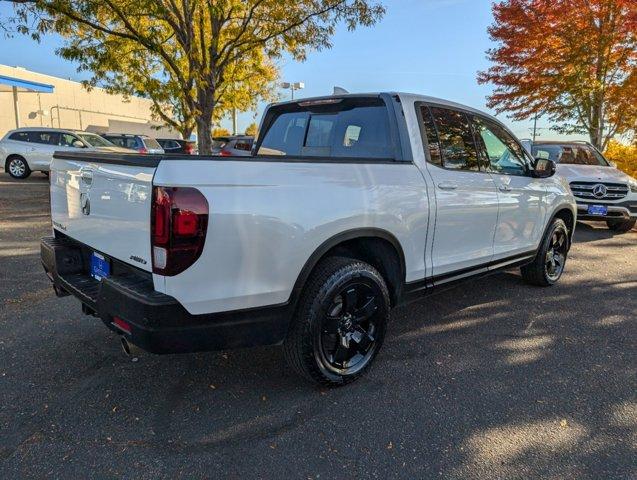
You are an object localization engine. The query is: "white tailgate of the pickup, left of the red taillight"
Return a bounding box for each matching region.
[50,152,159,271]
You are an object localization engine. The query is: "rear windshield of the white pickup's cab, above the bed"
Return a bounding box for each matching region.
[257,98,393,159]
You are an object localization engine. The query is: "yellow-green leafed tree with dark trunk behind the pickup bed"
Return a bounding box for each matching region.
[7,0,384,154]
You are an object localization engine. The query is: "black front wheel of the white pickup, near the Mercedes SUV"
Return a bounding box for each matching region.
[520,218,570,287]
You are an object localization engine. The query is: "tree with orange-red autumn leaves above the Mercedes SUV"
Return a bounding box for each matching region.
[478,0,637,150]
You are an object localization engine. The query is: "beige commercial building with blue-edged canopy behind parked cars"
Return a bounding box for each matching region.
[0,65,179,138]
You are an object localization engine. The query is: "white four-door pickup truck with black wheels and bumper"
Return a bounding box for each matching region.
[41,93,576,385]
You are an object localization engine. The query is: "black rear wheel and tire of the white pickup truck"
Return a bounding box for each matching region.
[284,257,390,386]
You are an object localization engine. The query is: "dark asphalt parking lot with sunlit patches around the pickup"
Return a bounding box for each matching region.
[0,173,637,479]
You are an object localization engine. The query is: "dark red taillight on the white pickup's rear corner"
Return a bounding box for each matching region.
[151,187,208,276]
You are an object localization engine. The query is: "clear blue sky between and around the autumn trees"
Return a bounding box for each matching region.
[0,0,576,139]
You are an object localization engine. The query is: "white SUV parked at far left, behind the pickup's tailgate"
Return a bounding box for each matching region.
[0,128,131,179]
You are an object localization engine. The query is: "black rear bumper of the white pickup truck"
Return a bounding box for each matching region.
[40,237,290,354]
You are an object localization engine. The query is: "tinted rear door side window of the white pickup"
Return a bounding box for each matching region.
[431,107,480,172]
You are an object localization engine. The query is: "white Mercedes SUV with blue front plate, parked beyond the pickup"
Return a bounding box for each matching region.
[531,142,637,233]
